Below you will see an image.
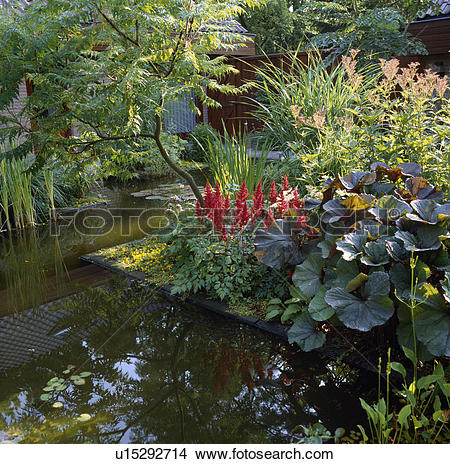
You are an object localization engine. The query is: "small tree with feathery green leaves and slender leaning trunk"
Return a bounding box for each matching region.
[0,0,261,203]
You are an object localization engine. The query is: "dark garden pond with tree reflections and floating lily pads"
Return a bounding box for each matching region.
[0,173,376,443]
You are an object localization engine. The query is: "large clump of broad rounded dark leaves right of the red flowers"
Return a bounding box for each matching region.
[256,163,450,359]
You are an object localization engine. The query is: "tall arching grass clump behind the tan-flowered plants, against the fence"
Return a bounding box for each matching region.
[250,52,375,151]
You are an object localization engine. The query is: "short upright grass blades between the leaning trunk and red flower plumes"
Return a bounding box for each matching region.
[204,128,272,195]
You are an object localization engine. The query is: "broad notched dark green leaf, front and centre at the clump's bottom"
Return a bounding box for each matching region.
[325,271,394,332]
